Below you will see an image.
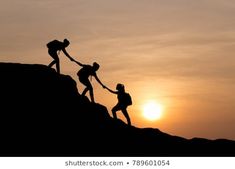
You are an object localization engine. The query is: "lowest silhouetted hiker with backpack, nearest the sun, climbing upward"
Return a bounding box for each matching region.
[105,83,132,125]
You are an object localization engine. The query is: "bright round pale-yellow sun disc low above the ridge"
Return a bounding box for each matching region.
[143,101,163,121]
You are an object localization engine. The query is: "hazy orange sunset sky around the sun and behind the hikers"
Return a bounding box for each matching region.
[0,0,235,140]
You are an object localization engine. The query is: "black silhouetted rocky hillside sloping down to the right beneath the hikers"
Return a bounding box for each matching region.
[0,63,235,156]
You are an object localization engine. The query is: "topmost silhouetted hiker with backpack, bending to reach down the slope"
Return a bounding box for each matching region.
[47,39,75,74]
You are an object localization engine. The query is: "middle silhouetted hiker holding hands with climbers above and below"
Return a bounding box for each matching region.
[75,61,105,103]
